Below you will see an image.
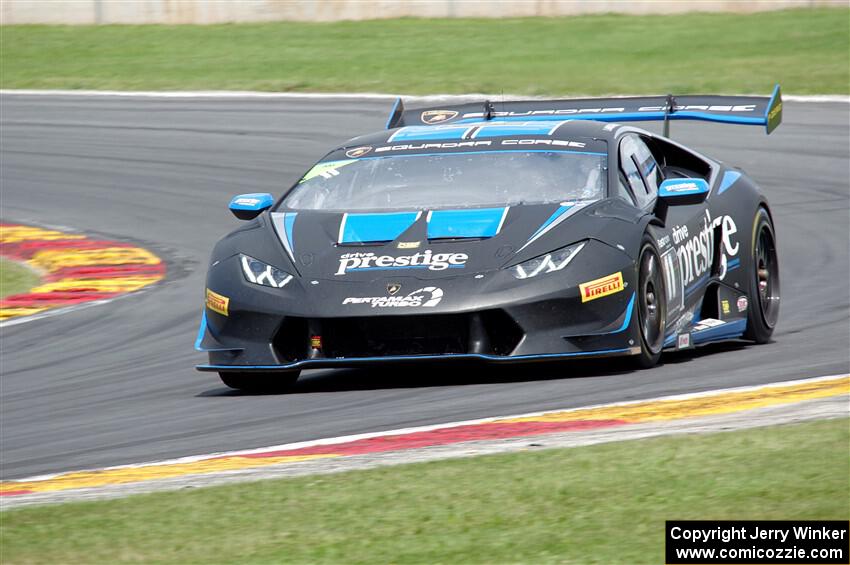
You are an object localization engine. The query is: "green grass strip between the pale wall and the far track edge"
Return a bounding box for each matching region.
[0,8,850,95]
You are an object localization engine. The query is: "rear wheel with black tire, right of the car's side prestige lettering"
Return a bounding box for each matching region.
[744,207,779,343]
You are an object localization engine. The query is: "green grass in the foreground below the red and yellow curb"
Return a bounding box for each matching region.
[0,419,850,564]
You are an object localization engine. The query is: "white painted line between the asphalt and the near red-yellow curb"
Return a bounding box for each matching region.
[9,374,848,483]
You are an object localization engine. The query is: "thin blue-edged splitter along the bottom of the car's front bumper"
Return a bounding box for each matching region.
[195,347,630,371]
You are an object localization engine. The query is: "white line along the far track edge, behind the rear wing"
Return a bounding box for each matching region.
[0,89,850,104]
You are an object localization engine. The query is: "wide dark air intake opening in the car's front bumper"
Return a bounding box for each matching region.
[275,310,523,359]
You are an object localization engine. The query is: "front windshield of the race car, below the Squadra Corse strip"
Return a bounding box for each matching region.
[282,151,606,212]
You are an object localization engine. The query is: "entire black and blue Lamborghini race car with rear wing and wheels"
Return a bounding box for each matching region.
[196,86,782,389]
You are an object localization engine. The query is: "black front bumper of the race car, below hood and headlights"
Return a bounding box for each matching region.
[196,237,640,371]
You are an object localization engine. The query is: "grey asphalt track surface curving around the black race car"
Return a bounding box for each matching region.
[0,94,850,479]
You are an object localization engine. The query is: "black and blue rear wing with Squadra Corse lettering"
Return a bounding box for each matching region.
[387,84,782,135]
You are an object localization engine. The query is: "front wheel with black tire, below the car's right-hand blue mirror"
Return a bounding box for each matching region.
[634,235,667,369]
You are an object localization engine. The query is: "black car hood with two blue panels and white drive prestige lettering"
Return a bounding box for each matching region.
[271,200,635,282]
